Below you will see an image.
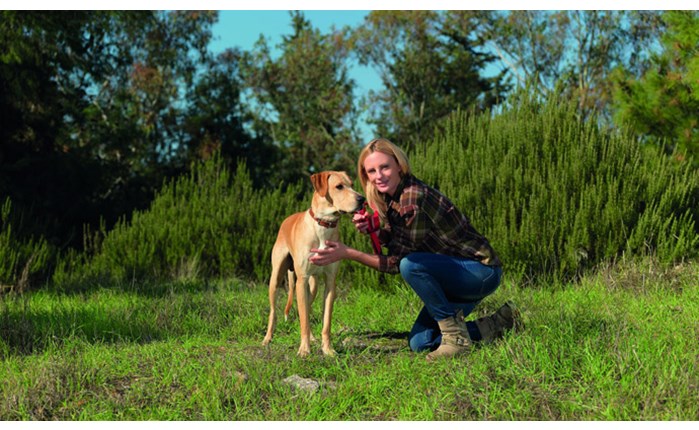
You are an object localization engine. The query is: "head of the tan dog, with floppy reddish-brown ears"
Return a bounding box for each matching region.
[311,171,366,215]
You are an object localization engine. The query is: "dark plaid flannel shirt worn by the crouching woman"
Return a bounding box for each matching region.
[379,175,501,274]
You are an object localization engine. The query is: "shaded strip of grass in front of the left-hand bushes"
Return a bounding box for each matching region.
[0,281,256,359]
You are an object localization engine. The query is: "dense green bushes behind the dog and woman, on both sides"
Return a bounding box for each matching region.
[20,92,699,286]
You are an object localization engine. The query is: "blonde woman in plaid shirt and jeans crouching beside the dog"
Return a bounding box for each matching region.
[310,138,518,360]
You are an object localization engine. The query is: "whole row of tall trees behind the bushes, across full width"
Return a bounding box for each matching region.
[0,11,697,266]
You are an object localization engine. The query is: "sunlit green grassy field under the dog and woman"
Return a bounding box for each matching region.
[0,261,699,421]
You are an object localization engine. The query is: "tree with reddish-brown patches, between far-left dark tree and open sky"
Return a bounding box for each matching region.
[75,12,216,176]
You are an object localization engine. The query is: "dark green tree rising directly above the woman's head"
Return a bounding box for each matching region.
[354,11,507,147]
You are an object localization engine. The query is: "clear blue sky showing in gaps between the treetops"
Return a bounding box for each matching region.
[210,10,381,139]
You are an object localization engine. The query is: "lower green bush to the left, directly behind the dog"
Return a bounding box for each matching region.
[56,156,304,285]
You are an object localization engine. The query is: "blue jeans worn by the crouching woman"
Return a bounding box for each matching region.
[400,252,502,351]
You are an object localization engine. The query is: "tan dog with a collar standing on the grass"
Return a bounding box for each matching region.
[262,171,365,356]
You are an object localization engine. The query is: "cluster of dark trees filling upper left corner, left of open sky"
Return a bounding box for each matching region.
[0,11,266,247]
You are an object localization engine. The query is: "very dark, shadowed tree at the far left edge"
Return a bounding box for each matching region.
[0,11,149,244]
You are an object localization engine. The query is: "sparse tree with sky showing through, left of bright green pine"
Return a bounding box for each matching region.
[483,10,662,118]
